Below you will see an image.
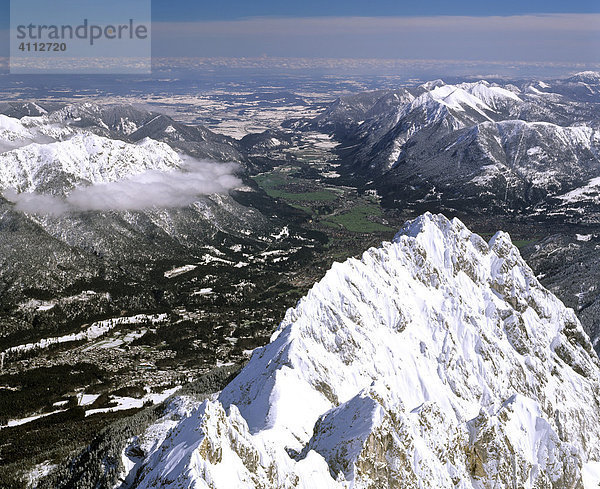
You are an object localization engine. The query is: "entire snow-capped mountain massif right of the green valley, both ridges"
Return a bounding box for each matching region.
[296,73,600,212]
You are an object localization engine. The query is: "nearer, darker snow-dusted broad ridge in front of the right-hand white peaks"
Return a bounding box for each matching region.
[350,120,600,213]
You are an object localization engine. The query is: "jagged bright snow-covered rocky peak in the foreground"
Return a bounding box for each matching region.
[123,214,600,488]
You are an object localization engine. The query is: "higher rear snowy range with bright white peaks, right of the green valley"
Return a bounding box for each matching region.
[296,73,600,191]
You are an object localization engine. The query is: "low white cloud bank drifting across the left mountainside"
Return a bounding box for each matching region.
[2,159,242,216]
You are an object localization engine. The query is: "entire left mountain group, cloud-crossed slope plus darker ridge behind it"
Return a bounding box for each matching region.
[0,103,310,341]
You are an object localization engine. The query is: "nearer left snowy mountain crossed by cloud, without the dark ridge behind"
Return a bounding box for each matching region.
[0,123,279,308]
